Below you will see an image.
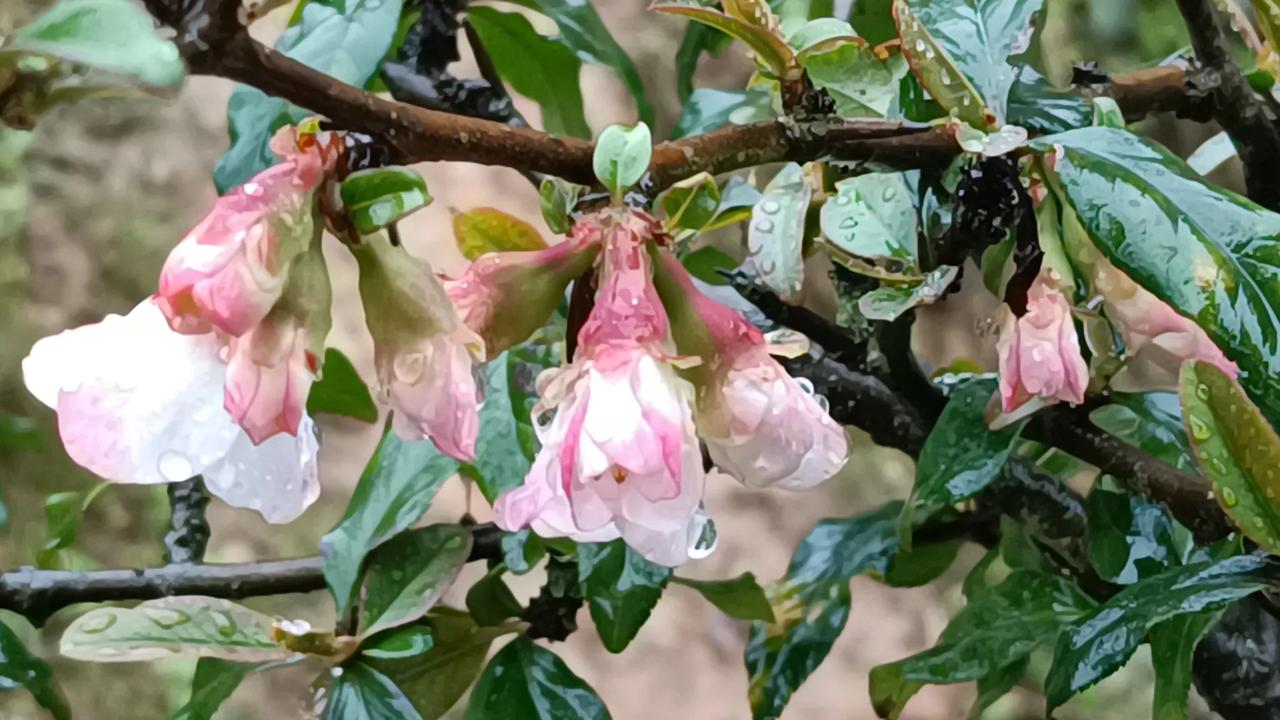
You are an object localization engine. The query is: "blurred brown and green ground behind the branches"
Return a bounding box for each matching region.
[0,0,1239,720]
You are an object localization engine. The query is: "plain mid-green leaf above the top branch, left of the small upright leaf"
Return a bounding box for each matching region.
[467,5,591,137]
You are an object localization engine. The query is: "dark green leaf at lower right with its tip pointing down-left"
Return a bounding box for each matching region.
[870,570,1094,719]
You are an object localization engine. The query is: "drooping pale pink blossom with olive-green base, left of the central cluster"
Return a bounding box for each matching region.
[352,234,484,460]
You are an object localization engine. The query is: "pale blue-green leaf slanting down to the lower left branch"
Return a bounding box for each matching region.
[320,433,458,616]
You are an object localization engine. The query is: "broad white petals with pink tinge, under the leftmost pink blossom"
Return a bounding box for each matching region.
[22,300,320,523]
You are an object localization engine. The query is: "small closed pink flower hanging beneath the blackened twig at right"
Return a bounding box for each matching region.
[996,273,1089,413]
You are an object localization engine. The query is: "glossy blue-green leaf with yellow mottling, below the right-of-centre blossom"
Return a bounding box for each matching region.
[745,502,901,720]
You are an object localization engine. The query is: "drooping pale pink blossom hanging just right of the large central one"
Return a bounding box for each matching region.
[658,252,849,489]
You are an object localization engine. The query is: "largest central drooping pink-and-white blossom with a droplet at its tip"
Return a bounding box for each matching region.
[494,210,705,566]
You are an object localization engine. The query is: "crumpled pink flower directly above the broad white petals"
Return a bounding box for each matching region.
[156,127,333,337]
